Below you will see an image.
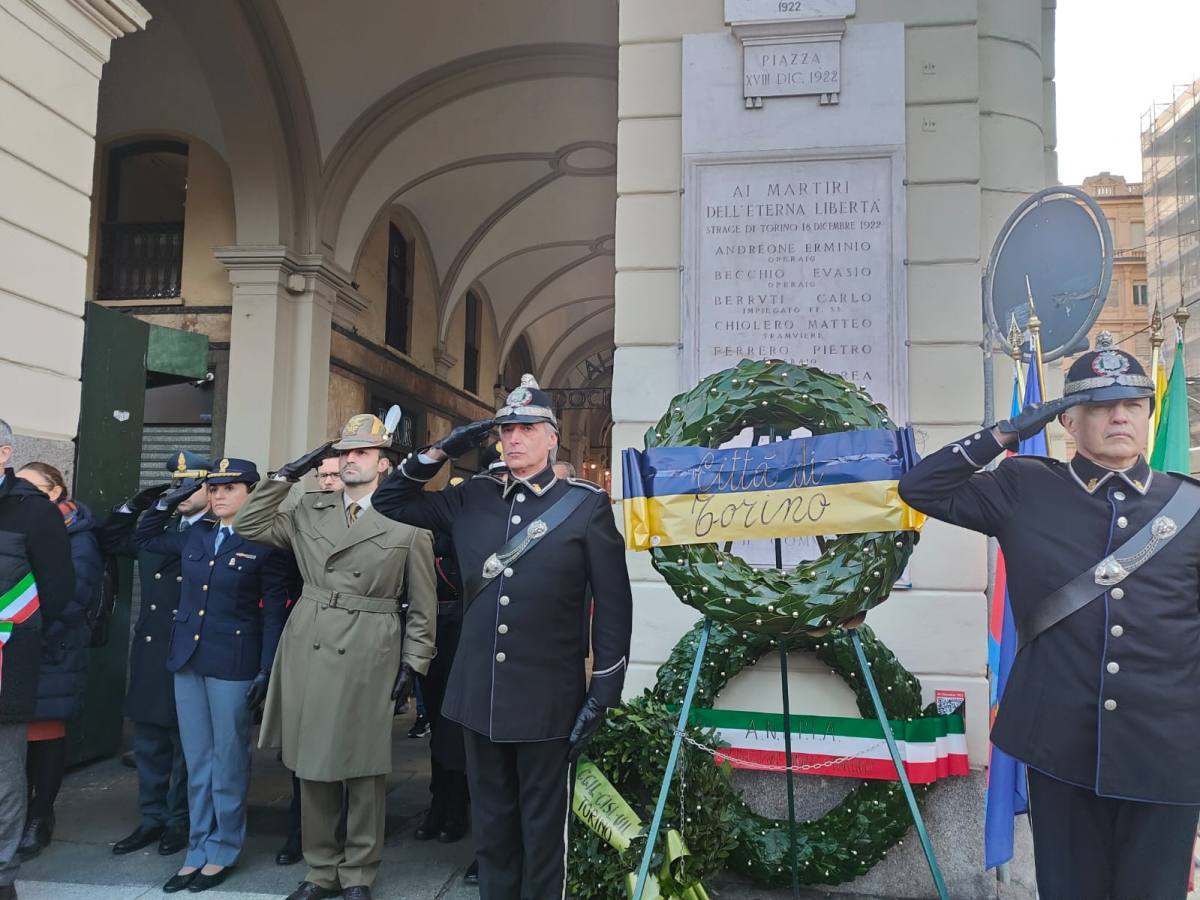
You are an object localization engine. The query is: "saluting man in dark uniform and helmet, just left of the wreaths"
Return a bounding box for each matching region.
[374,376,632,900]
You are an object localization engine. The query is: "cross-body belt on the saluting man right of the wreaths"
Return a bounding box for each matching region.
[1016,481,1200,650]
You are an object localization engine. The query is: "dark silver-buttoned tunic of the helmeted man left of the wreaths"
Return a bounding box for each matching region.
[372,456,632,742]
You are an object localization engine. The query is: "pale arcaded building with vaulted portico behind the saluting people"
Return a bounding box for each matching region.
[0,0,1056,898]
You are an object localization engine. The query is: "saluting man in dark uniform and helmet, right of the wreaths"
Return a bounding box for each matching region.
[900,334,1200,900]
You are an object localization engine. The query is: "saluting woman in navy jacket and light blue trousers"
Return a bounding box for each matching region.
[134,458,287,893]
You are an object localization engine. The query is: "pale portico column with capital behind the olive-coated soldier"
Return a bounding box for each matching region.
[216,246,355,470]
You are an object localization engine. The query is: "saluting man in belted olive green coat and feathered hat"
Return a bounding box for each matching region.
[234,415,437,900]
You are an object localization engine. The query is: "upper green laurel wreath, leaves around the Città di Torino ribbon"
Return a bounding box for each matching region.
[646,360,918,637]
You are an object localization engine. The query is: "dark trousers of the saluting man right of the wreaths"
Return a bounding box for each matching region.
[1027,768,1200,900]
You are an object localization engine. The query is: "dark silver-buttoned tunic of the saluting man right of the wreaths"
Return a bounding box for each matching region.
[900,431,1200,804]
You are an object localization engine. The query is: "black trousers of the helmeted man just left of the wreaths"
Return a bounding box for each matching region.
[463,728,575,900]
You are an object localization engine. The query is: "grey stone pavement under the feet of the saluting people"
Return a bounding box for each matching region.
[17,713,479,900]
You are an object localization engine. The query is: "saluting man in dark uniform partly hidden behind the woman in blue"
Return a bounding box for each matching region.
[102,450,210,856]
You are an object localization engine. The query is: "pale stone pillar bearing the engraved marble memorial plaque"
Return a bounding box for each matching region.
[613,0,1054,898]
